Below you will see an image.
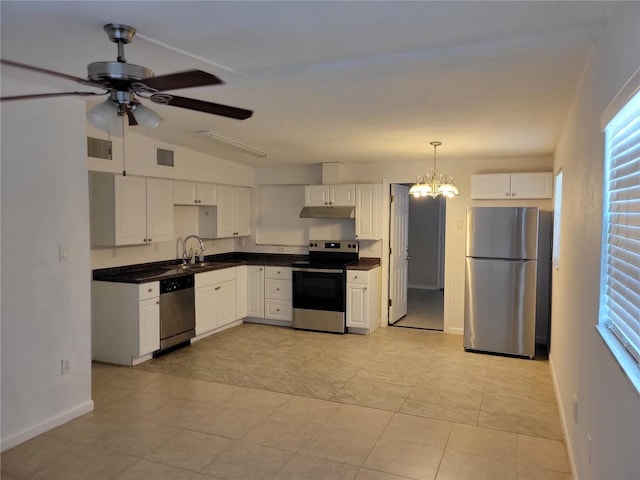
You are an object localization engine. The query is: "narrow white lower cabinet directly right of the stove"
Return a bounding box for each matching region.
[347,267,380,333]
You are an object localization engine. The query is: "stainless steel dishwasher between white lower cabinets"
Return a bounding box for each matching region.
[157,275,196,354]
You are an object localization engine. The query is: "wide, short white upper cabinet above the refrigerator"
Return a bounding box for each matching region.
[471,172,553,200]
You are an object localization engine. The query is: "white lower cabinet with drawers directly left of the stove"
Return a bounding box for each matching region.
[247,266,293,325]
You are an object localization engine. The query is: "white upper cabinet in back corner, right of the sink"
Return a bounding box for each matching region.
[216,185,251,238]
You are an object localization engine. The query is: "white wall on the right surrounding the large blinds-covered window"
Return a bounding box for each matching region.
[551,2,640,480]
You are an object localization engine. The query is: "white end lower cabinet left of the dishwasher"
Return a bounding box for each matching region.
[91,281,160,366]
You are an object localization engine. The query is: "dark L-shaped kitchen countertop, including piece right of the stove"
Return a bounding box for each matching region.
[93,252,380,283]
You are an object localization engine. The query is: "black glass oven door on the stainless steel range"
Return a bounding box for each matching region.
[292,267,345,312]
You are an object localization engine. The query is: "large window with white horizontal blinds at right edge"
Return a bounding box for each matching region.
[599,92,640,391]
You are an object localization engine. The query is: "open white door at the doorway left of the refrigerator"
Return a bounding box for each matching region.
[389,185,409,325]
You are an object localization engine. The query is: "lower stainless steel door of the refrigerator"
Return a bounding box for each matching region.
[464,257,537,358]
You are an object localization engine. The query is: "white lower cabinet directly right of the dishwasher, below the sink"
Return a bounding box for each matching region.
[194,267,237,336]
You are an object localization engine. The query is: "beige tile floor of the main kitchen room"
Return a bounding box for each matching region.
[1,324,571,480]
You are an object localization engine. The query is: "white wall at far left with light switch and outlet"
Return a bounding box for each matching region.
[1,77,93,450]
